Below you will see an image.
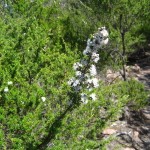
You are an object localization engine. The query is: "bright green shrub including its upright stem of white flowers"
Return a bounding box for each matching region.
[0,0,148,150]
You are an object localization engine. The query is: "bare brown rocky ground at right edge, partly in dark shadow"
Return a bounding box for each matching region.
[103,48,150,150]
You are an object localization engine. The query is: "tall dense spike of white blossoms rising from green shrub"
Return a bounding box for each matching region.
[68,27,108,104]
